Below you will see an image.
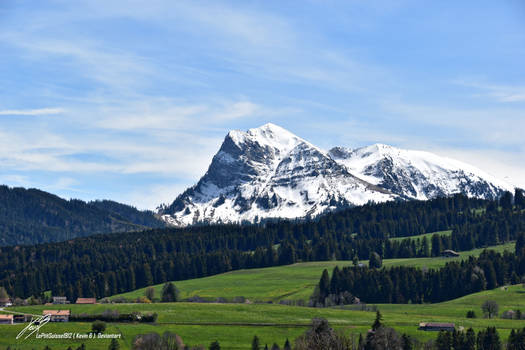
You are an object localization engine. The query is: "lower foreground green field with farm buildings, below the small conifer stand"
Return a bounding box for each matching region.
[4,285,525,349]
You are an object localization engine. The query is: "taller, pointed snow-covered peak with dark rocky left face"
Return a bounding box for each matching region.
[160,124,396,226]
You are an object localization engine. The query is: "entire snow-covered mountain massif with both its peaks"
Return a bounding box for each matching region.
[159,124,513,226]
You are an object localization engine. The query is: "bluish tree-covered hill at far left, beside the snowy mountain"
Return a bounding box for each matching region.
[0,186,164,246]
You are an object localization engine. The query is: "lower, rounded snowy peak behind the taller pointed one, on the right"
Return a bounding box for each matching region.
[329,144,514,200]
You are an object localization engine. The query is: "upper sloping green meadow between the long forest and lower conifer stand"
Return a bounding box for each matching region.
[108,243,514,302]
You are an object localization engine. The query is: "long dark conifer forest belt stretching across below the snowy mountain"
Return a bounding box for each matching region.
[0,194,525,302]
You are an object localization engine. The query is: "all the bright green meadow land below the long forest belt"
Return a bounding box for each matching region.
[0,243,525,350]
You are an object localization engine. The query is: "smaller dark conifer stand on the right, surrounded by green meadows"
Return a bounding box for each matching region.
[313,245,525,306]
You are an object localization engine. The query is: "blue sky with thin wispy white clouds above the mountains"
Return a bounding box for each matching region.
[0,0,525,208]
